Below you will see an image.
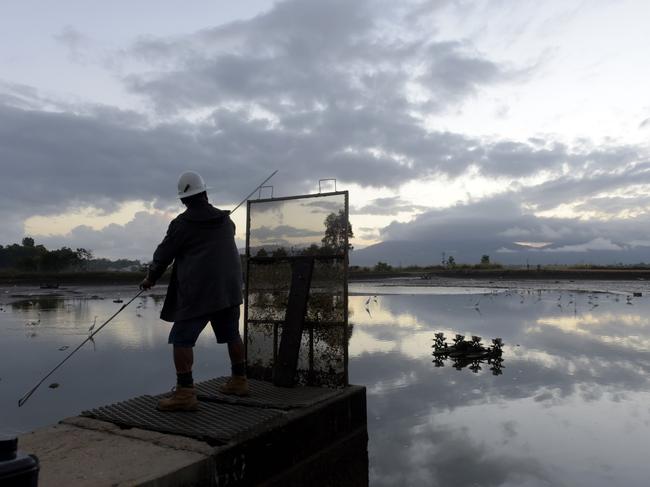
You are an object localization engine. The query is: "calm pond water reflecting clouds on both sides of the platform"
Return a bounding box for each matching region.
[0,283,650,486]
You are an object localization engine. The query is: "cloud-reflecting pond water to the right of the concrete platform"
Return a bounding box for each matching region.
[350,290,650,486]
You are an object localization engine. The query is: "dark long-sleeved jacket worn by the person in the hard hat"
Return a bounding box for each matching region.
[147,201,242,321]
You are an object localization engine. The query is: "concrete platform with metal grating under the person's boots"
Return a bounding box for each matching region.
[19,378,368,487]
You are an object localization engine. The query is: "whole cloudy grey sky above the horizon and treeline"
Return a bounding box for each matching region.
[0,0,650,260]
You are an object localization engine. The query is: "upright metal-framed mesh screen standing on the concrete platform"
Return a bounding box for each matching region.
[244,191,350,387]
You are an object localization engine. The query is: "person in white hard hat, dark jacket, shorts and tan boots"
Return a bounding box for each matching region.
[140,171,248,411]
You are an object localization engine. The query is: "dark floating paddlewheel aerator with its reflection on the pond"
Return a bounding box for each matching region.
[432,333,503,375]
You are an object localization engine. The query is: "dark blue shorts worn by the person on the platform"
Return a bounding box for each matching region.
[168,305,239,347]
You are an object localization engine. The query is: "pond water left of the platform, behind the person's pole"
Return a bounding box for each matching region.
[0,290,229,434]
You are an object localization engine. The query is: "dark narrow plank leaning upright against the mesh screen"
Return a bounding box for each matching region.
[273,256,314,387]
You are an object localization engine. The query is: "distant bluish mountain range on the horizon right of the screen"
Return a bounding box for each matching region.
[350,239,650,266]
